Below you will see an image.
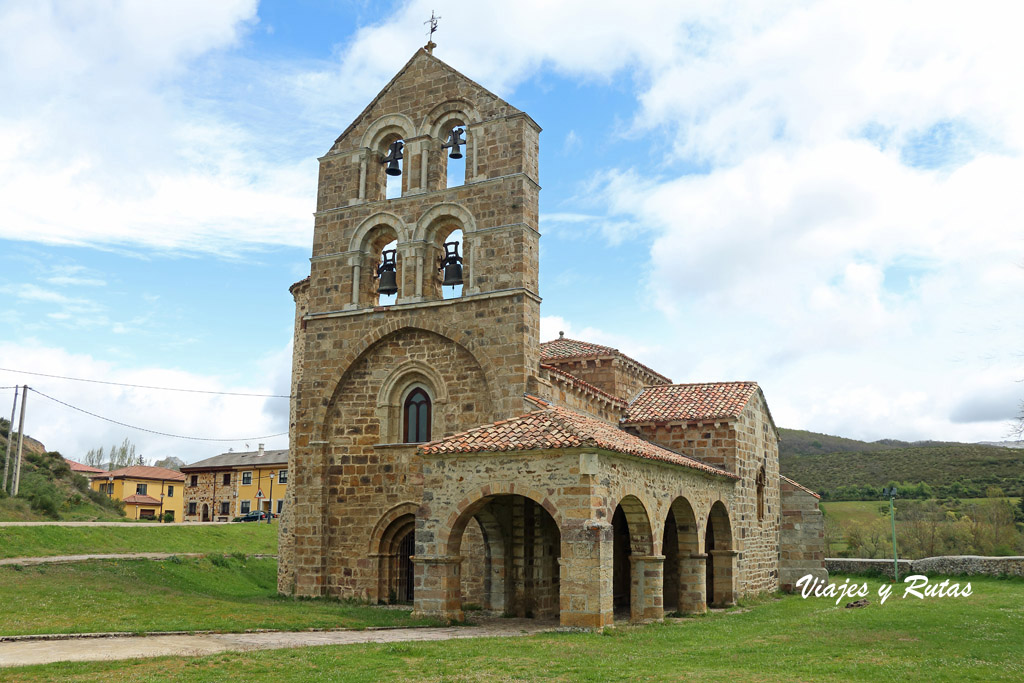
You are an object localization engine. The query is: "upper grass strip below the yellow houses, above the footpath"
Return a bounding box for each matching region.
[0,522,278,558]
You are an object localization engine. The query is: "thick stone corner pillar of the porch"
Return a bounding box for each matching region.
[558,519,615,629]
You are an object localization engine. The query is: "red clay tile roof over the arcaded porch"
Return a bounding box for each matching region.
[419,403,738,479]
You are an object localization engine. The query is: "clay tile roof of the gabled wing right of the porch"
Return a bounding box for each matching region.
[623,382,758,424]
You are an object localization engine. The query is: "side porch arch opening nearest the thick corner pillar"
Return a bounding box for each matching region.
[611,496,660,622]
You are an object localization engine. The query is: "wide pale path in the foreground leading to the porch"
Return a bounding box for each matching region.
[0,617,558,667]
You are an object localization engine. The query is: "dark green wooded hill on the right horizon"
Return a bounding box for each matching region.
[779,429,1024,500]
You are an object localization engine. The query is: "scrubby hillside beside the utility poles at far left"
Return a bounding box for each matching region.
[0,420,124,521]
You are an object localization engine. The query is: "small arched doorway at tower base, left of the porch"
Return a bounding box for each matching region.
[370,503,419,603]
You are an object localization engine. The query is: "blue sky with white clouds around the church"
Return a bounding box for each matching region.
[0,0,1024,462]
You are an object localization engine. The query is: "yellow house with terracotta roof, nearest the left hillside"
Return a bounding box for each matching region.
[90,465,185,521]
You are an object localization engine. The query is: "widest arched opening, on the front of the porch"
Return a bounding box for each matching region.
[449,495,561,618]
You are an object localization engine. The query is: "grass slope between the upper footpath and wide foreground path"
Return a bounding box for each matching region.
[0,556,436,635]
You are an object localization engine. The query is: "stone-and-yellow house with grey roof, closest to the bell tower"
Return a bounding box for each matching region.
[181,443,288,522]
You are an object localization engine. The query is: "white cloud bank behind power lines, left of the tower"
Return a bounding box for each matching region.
[0,340,290,462]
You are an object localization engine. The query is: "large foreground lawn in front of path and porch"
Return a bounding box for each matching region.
[0,579,1024,683]
